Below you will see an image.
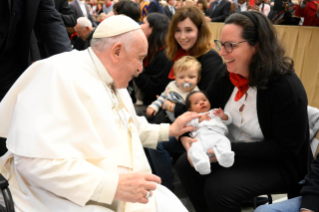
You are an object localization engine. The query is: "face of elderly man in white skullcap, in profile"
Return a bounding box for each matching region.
[114,30,148,88]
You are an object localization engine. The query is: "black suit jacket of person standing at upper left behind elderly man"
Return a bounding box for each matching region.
[0,0,72,101]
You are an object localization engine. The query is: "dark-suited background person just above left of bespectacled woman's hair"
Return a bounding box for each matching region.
[205,0,231,22]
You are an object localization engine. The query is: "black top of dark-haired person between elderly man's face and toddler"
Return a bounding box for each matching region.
[134,50,173,105]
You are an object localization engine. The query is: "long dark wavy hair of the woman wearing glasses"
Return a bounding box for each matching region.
[225,11,294,89]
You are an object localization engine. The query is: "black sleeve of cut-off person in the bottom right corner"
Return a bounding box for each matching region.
[300,154,319,211]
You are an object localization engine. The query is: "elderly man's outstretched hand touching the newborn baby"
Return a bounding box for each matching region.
[169,112,200,137]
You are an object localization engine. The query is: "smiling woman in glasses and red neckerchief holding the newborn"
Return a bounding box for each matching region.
[176,11,312,212]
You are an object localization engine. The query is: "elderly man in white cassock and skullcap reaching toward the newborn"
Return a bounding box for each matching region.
[0,16,198,212]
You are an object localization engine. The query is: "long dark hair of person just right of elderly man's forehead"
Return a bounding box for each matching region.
[146,13,169,63]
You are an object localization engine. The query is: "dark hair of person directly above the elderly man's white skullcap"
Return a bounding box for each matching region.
[113,0,141,22]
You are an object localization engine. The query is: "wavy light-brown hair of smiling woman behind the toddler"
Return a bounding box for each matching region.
[166,6,212,61]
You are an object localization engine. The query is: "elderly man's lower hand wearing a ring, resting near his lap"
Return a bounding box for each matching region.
[114,173,161,204]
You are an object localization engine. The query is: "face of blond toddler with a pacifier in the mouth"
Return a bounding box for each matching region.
[175,68,198,92]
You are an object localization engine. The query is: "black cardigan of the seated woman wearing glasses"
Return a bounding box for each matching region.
[206,72,312,195]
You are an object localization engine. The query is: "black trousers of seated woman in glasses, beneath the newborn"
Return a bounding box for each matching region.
[176,154,287,212]
